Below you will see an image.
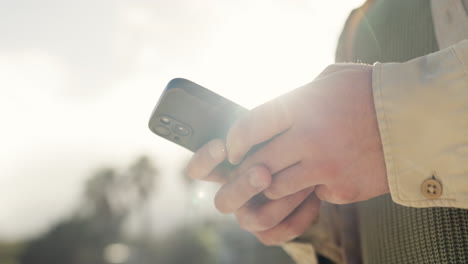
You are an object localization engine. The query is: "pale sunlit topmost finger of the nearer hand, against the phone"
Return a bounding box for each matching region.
[226,98,292,164]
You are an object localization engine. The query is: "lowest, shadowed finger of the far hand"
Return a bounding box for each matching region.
[254,194,320,245]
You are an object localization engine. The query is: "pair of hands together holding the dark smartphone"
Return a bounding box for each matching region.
[187,64,388,244]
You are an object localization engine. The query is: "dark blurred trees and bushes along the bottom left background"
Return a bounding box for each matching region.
[0,157,293,264]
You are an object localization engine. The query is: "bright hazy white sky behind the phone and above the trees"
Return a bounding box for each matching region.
[0,0,363,240]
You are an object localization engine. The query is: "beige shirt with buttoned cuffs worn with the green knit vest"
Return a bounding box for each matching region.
[283,0,468,264]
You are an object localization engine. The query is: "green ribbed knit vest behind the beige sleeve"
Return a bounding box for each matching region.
[336,0,468,264]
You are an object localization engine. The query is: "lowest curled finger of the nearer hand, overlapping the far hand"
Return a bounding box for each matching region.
[263,162,322,200]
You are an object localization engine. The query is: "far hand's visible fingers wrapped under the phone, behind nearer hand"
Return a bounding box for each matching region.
[186,139,320,245]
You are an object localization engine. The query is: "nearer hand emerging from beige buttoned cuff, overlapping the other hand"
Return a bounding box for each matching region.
[221,64,389,204]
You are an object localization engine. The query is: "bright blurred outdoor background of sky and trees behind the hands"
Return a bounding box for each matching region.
[0,0,363,264]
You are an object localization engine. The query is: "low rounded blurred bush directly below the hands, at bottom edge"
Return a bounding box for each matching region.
[157,220,294,264]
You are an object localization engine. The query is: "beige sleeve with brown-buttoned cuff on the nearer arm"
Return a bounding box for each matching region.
[372,40,468,208]
